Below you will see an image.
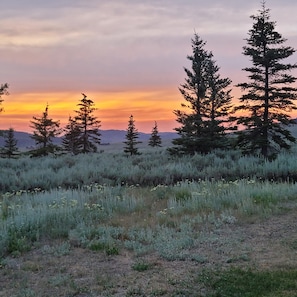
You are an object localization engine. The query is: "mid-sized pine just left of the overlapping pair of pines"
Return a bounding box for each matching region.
[30,105,62,156]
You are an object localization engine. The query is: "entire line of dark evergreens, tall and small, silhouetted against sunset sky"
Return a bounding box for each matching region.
[0,1,297,159]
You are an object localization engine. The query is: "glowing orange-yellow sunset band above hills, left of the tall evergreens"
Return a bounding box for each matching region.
[0,89,181,133]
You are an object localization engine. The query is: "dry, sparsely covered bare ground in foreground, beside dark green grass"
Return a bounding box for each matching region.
[0,206,297,297]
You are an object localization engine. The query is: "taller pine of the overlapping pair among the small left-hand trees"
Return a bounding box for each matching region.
[74,94,101,153]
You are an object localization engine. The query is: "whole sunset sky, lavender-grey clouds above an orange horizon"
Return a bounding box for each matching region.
[0,0,297,133]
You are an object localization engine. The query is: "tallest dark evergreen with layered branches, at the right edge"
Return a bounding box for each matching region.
[236,2,297,158]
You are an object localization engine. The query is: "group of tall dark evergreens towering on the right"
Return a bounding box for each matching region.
[170,2,297,158]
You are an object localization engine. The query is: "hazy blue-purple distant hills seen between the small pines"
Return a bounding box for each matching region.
[0,130,177,149]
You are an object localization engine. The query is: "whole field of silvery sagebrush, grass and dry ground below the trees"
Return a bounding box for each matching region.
[0,146,297,297]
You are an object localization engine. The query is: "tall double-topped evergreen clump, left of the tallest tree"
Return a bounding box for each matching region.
[169,34,232,154]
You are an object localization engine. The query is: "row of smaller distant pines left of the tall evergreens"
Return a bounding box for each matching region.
[3,94,162,157]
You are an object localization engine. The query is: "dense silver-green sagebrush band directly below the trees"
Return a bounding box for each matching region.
[0,149,297,193]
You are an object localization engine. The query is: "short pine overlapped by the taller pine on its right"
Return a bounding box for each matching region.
[62,116,81,155]
